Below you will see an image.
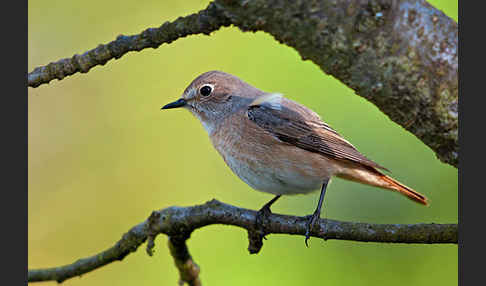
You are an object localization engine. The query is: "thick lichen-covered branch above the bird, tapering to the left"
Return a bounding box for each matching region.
[28,0,459,168]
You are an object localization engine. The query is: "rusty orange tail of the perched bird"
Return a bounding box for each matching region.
[338,167,429,206]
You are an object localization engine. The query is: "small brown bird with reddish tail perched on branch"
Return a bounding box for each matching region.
[162,71,427,245]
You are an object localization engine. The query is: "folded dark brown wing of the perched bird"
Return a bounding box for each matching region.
[247,94,387,170]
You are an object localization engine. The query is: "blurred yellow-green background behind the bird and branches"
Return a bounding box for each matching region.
[28,0,458,286]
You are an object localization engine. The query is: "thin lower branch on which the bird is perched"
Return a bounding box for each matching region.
[28,200,458,285]
